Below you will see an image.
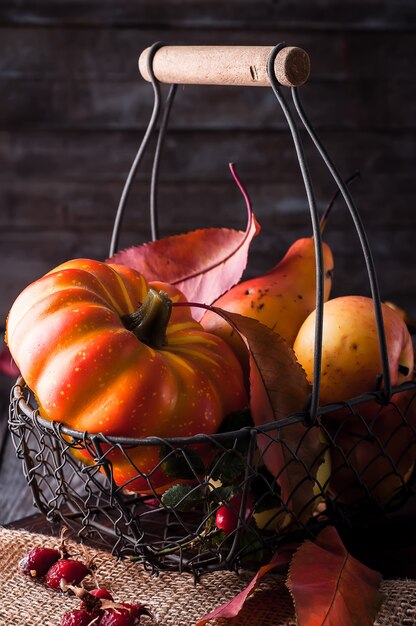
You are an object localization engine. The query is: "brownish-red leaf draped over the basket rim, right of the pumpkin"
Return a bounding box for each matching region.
[212,307,325,526]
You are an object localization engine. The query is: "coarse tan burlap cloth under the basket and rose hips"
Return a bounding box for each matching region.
[0,528,416,626]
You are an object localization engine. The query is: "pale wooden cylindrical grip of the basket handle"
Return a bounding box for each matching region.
[139,46,310,87]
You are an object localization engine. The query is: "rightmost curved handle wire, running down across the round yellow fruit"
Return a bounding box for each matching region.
[291,87,392,402]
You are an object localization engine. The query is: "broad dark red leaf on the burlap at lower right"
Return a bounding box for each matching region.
[286,526,383,626]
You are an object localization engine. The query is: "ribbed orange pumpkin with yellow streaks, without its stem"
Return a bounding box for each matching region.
[6,259,247,491]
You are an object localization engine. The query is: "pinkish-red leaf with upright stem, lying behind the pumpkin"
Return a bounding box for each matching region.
[107,165,260,316]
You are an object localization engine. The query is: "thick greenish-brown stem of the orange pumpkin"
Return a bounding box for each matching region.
[122,289,172,348]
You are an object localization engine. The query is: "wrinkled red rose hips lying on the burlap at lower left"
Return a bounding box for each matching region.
[19,539,151,626]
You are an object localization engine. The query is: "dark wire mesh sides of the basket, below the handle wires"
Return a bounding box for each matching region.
[9,383,416,576]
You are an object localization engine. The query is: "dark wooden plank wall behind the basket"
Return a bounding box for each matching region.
[0,0,416,325]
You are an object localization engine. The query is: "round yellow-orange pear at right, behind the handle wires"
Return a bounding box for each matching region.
[293,296,414,404]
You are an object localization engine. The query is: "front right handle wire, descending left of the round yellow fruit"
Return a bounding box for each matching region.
[267,43,324,424]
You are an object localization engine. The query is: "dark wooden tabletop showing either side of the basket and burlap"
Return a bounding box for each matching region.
[0,366,416,578]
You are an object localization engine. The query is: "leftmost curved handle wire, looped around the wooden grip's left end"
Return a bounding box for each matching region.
[109,42,164,257]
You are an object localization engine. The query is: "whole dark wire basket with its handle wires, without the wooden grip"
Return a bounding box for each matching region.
[9,44,416,576]
